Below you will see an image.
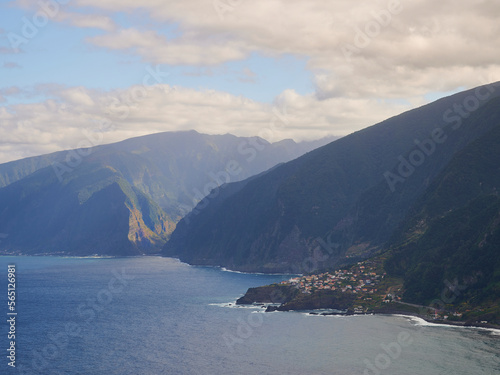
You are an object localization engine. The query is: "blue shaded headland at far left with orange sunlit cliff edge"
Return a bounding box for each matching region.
[0,160,173,255]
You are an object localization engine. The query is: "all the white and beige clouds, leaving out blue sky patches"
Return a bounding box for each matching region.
[0,0,500,161]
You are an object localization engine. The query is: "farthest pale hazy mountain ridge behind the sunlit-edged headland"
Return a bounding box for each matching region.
[0,131,329,220]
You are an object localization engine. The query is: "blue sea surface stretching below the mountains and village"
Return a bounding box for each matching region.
[0,257,500,375]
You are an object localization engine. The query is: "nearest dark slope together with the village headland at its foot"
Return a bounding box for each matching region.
[237,110,500,329]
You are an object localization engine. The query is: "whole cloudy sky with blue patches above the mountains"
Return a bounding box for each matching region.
[0,0,500,163]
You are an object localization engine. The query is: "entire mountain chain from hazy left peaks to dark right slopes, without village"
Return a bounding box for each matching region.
[0,83,500,319]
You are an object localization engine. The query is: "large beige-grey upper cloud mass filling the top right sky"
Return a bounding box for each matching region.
[70,0,500,98]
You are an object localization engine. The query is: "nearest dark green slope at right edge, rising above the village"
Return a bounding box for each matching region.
[385,117,500,314]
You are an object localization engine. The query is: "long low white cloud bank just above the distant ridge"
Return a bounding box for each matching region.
[0,84,404,162]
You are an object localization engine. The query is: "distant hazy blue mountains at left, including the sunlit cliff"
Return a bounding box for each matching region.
[0,131,331,255]
